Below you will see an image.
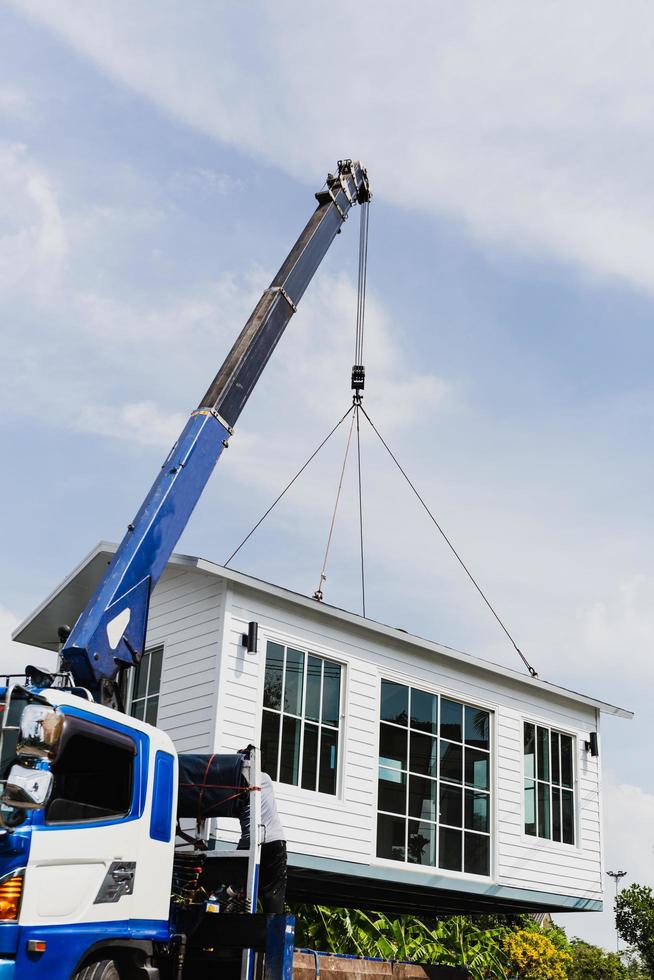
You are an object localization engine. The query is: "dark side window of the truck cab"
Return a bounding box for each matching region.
[46,721,136,824]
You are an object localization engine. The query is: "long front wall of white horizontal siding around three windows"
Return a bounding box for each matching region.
[214,579,602,899]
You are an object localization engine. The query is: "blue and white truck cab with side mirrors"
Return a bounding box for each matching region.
[0,685,177,980]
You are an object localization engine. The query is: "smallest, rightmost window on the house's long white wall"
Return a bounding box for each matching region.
[524,721,575,844]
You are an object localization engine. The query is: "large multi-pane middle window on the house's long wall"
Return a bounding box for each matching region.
[377,680,491,875]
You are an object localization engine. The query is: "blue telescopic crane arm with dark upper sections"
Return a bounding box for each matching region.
[61,160,370,704]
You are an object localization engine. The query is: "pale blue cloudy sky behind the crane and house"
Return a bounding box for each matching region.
[0,0,654,948]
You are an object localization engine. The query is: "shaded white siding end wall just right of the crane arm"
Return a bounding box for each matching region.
[146,565,225,752]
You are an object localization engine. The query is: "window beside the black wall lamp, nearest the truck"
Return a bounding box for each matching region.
[261,641,341,795]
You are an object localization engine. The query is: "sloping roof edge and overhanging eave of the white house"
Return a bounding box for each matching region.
[12,541,633,718]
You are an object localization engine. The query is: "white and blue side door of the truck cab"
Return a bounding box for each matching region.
[20,706,174,938]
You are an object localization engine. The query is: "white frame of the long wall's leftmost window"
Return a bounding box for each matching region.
[257,626,349,810]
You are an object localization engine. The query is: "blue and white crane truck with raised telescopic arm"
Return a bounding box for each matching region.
[0,160,472,980]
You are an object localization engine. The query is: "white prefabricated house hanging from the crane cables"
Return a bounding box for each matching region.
[14,543,631,912]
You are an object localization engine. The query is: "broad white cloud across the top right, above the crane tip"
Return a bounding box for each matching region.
[14,0,654,291]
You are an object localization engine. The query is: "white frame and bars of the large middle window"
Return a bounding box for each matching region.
[370,670,499,882]
